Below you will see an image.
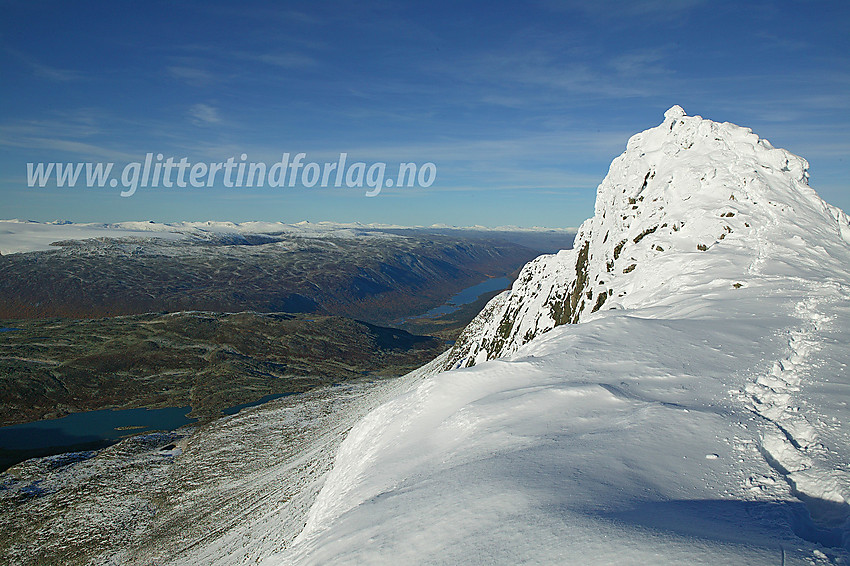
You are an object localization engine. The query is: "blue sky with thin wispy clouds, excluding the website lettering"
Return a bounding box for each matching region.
[0,0,850,227]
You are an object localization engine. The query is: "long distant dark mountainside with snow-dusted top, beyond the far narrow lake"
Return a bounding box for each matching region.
[0,232,537,324]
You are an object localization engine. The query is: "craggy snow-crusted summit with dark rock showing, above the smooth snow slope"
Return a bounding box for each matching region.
[448,106,850,367]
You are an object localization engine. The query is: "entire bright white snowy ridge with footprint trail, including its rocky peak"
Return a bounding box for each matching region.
[264,107,850,564]
